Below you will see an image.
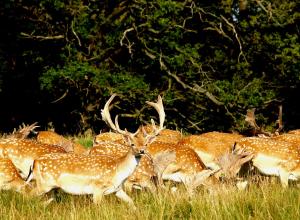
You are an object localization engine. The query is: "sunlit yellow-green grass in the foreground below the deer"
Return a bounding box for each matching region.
[0,184,300,220]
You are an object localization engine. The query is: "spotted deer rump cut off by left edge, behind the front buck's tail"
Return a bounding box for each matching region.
[0,158,27,192]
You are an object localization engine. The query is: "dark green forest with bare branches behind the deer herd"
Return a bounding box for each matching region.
[0,0,300,134]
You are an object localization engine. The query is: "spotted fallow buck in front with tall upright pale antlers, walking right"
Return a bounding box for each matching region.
[28,94,165,205]
